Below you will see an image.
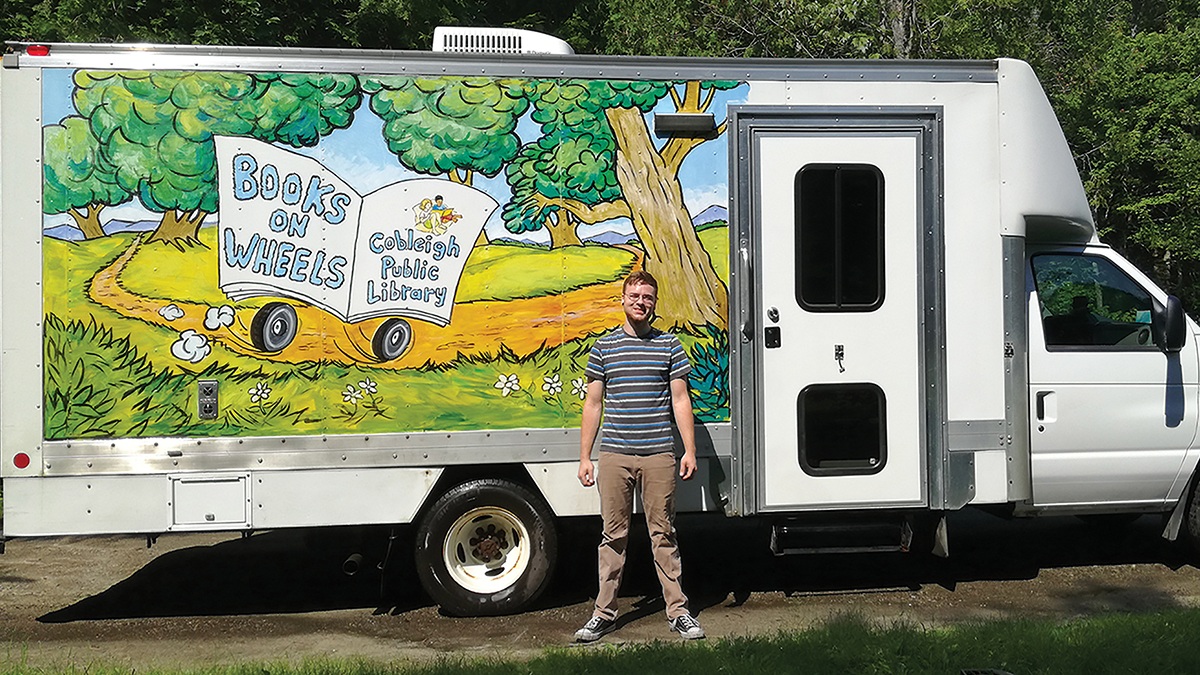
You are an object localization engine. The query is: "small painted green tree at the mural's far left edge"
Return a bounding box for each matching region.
[42,115,133,239]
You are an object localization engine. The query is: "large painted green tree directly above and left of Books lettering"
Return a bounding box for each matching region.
[74,71,361,247]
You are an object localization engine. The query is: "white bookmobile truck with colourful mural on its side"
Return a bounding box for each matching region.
[0,30,1200,614]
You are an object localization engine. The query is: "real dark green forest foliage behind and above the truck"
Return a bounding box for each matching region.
[0,0,1200,305]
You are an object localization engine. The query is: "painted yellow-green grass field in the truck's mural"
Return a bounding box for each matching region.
[43,227,728,440]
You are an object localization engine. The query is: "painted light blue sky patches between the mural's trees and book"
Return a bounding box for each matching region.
[42,68,749,243]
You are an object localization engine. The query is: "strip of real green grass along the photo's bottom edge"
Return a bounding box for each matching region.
[0,609,1200,675]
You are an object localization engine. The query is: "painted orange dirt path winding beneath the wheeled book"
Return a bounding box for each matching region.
[88,239,642,370]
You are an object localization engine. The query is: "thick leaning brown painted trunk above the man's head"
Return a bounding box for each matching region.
[605,108,728,330]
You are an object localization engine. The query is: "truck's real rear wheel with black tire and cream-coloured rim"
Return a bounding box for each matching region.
[415,478,558,616]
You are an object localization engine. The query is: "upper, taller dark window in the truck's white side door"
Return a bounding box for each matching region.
[794,165,883,311]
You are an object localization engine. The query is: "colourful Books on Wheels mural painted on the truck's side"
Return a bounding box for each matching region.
[42,68,749,440]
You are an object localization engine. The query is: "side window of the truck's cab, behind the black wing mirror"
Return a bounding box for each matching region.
[1030,253,1157,350]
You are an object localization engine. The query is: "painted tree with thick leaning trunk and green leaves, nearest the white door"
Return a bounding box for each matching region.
[533,79,739,330]
